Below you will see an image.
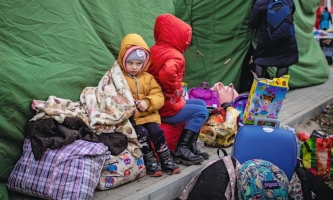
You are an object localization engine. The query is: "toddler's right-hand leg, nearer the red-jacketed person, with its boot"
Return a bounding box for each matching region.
[144,122,180,174]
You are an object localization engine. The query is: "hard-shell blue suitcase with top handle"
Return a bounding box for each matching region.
[231,118,297,181]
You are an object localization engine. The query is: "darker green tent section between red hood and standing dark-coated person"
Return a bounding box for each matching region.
[176,0,252,88]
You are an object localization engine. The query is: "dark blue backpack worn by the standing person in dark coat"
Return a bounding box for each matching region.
[267,0,295,41]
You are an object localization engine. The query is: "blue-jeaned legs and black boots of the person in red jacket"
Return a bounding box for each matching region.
[162,99,209,165]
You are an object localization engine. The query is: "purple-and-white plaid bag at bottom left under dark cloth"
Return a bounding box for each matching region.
[7,139,110,200]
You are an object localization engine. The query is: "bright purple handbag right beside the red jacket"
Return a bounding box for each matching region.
[188,82,219,107]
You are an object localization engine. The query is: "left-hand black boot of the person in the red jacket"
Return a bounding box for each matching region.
[172,129,204,165]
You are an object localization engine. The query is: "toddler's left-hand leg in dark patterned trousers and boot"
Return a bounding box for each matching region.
[134,125,163,176]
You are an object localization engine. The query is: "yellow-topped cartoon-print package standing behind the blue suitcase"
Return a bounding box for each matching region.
[243,72,290,124]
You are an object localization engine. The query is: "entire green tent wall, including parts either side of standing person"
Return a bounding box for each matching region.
[0,0,329,199]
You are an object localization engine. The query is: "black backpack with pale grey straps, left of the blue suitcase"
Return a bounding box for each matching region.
[179,149,240,200]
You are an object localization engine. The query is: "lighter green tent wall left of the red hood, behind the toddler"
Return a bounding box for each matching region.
[0,0,175,199]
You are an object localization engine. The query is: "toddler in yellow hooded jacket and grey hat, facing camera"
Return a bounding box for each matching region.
[117,34,180,176]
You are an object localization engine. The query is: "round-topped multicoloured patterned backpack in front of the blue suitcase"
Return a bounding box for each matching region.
[237,159,289,200]
